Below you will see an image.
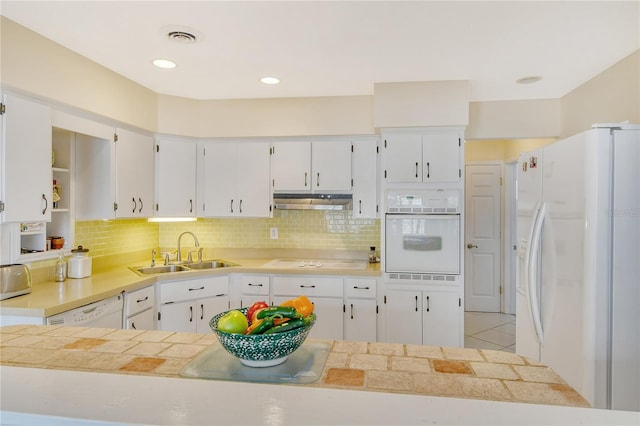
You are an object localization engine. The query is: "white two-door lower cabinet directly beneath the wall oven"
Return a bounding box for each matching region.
[384,289,464,347]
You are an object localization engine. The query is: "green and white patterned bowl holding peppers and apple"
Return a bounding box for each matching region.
[209,308,317,367]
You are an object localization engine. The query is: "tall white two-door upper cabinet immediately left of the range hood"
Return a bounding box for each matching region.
[198,142,271,217]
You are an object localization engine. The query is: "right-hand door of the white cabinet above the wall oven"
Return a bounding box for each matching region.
[422,132,462,182]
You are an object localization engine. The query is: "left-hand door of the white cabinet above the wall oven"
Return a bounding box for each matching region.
[382,133,422,182]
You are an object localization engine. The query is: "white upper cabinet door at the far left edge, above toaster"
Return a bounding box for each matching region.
[0,95,53,222]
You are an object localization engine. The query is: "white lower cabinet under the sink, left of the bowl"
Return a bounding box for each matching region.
[158,276,229,333]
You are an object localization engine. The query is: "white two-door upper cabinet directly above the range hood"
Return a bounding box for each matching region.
[271,140,351,192]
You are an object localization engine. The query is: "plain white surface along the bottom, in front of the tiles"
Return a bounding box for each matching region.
[0,366,640,426]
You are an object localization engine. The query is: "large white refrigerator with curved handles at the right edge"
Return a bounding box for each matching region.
[516,124,640,411]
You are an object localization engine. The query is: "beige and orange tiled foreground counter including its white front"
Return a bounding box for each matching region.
[0,325,640,425]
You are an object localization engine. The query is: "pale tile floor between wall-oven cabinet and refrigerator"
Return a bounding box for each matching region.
[464,312,516,352]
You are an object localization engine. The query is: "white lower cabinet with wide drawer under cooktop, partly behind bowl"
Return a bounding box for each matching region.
[271,276,344,340]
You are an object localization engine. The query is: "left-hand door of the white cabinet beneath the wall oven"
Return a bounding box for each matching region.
[384,290,422,345]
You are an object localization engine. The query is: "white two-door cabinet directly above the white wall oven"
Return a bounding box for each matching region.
[383,130,463,183]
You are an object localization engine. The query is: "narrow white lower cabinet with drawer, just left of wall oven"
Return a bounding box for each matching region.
[343,278,378,342]
